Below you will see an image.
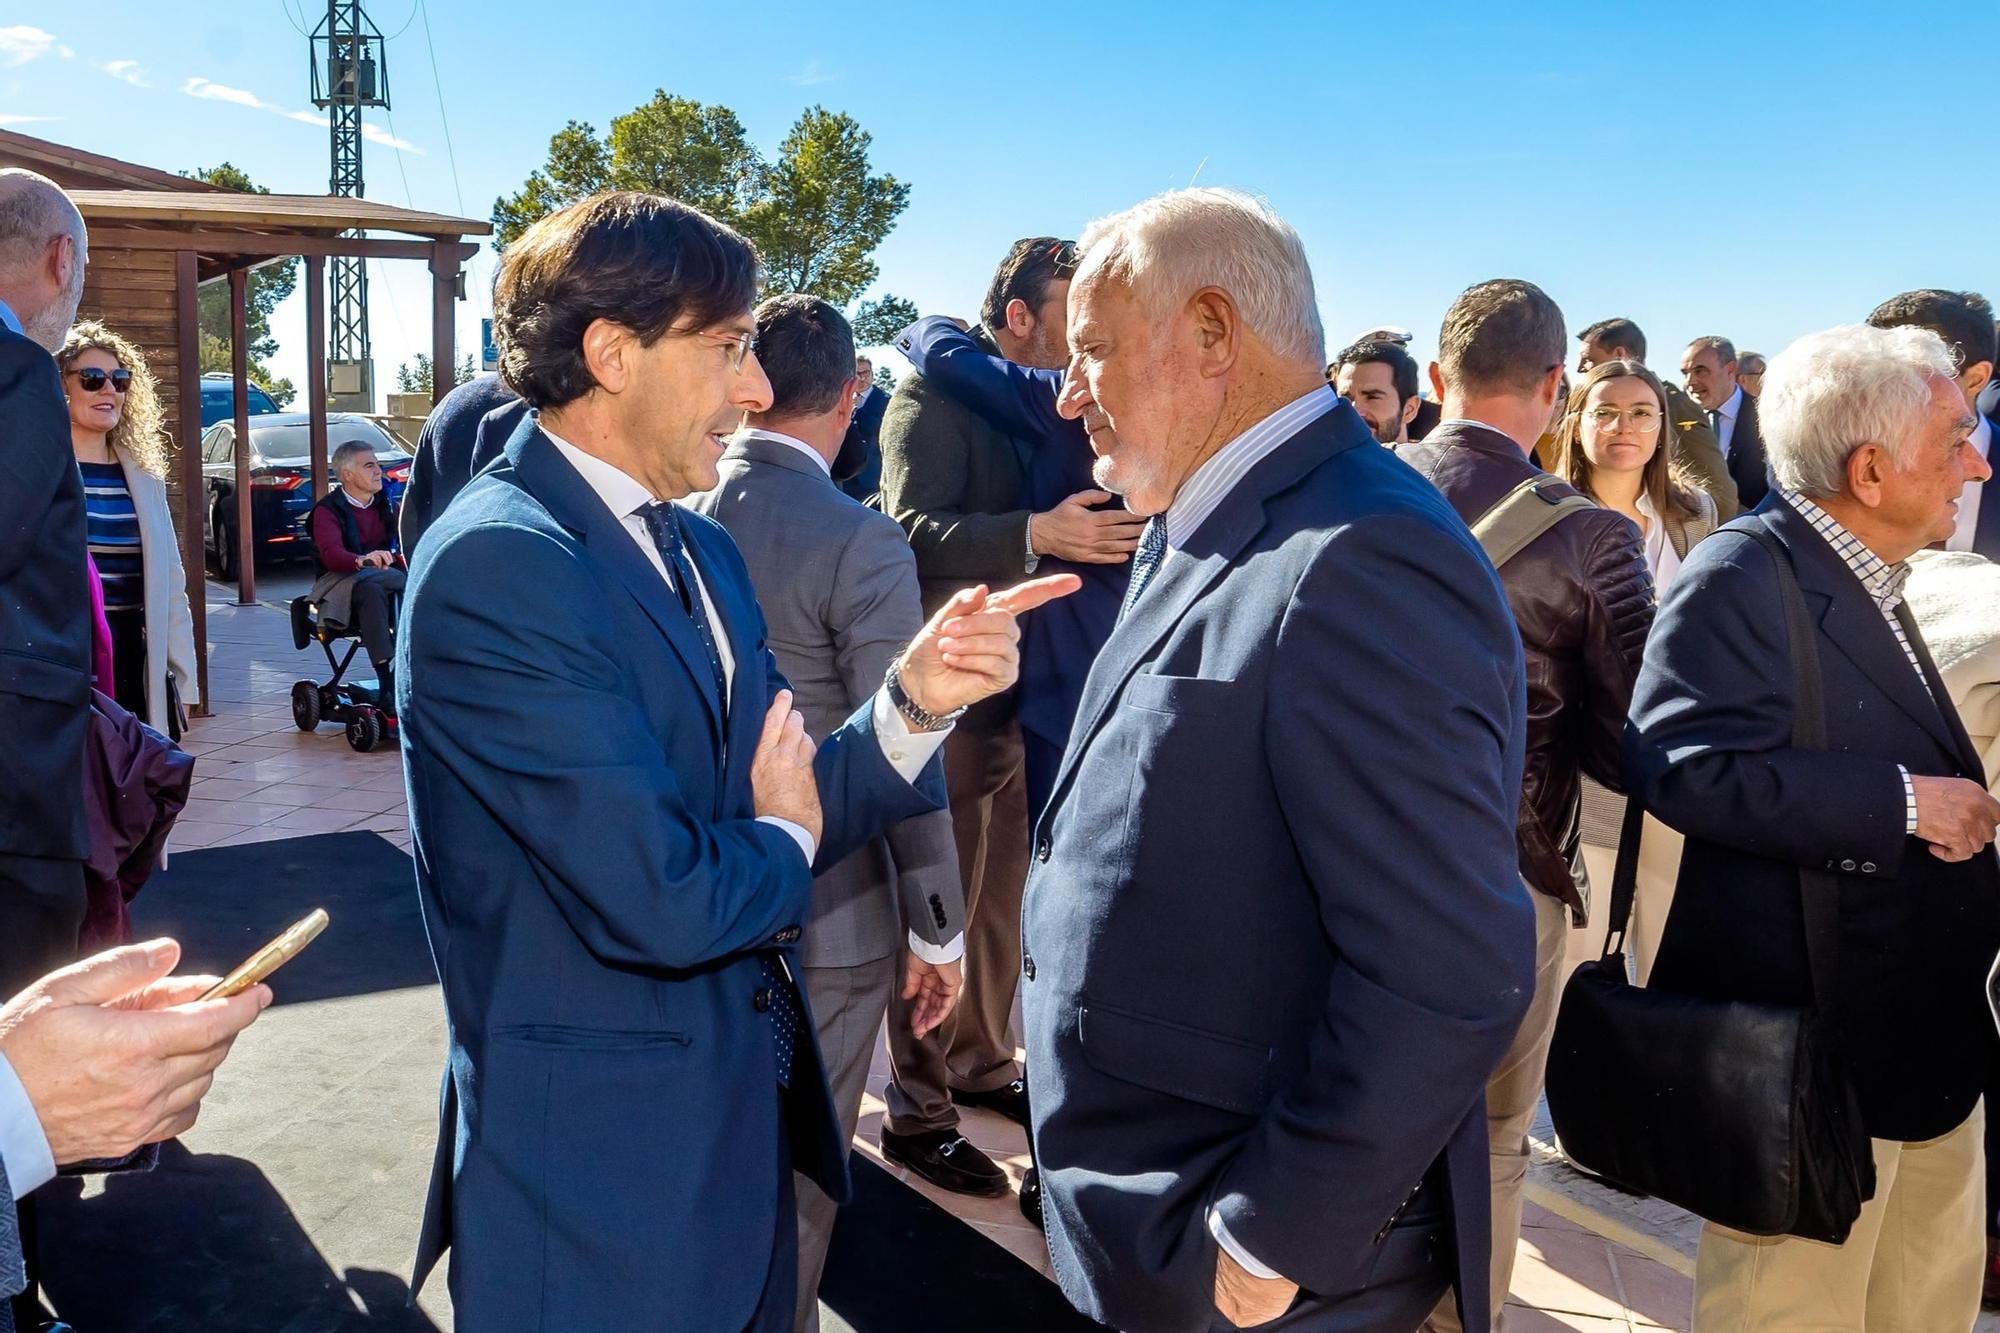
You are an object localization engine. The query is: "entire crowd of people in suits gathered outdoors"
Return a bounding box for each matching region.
[0,156,2000,1333]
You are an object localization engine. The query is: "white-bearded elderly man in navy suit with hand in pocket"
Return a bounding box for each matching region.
[1022,190,1534,1333]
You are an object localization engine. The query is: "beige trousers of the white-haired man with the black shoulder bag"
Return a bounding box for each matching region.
[1694,1107,1986,1333]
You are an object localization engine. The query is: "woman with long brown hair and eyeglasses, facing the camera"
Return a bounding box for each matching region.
[1548,360,1716,983]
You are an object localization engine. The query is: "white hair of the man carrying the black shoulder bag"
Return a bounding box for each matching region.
[1756,324,1958,498]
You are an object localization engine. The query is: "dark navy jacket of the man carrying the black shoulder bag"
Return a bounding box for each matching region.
[1626,490,2000,1141]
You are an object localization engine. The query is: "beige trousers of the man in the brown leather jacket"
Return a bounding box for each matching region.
[1424,889,1572,1333]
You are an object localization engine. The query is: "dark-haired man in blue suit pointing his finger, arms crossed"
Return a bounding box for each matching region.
[396,194,1074,1331]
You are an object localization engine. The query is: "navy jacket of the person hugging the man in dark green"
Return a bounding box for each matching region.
[896,316,1132,749]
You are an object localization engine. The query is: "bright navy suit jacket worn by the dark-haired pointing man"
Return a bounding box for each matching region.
[396,418,944,1329]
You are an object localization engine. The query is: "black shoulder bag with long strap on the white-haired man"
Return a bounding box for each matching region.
[1548,532,1876,1245]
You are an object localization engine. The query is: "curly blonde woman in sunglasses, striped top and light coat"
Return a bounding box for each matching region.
[56,320,196,739]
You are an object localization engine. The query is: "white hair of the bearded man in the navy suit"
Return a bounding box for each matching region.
[1076,186,1326,366]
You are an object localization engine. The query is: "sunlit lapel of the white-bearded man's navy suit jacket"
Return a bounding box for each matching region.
[1042,410,1372,821]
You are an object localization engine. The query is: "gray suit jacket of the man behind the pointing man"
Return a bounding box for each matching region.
[688,436,966,967]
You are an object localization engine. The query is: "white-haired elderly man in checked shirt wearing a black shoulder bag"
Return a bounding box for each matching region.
[1626,324,2000,1331]
